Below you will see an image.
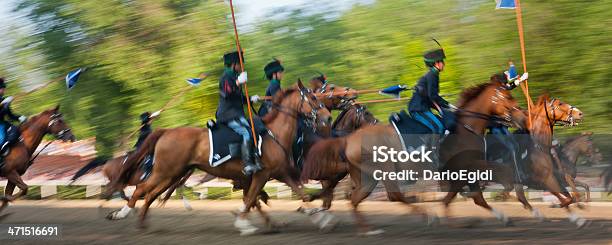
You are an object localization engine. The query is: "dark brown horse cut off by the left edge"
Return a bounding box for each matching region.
[0,106,76,212]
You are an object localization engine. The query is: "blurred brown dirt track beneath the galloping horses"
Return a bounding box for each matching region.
[0,200,612,245]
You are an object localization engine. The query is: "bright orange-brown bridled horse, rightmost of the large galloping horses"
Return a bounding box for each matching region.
[488,94,582,220]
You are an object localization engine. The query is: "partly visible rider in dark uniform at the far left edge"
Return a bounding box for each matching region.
[0,78,28,156]
